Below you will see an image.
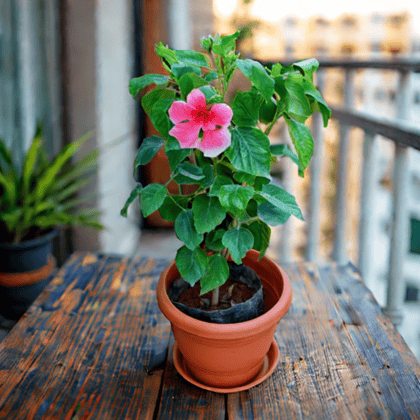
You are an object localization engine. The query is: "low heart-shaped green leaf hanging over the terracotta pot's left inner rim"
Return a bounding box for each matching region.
[175,246,208,286]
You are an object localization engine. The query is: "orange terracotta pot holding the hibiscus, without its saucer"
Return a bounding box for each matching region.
[156,250,292,388]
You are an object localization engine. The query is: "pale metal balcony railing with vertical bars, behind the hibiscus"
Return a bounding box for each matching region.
[294,60,420,325]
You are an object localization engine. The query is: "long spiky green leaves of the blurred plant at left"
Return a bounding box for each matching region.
[0,127,103,243]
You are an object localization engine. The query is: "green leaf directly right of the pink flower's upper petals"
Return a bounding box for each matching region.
[232,89,263,127]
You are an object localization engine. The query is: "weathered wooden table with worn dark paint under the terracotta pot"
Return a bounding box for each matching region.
[0,254,420,420]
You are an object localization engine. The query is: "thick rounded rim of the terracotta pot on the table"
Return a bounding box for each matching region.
[156,250,292,340]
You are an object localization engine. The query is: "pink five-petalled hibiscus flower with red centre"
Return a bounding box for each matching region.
[169,89,233,157]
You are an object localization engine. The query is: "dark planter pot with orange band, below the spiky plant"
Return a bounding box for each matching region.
[0,230,57,320]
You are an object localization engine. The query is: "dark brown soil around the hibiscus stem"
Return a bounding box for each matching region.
[178,279,255,311]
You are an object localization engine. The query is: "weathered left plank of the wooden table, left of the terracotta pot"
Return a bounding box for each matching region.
[0,254,170,419]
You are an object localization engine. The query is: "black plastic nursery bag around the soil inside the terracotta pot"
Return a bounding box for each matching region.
[168,261,263,324]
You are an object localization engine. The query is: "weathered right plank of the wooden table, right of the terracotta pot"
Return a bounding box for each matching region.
[228,264,420,419]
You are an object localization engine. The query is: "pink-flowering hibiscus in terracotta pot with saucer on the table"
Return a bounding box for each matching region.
[121,32,331,392]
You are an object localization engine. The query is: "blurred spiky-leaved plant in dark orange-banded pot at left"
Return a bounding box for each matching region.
[0,127,103,319]
